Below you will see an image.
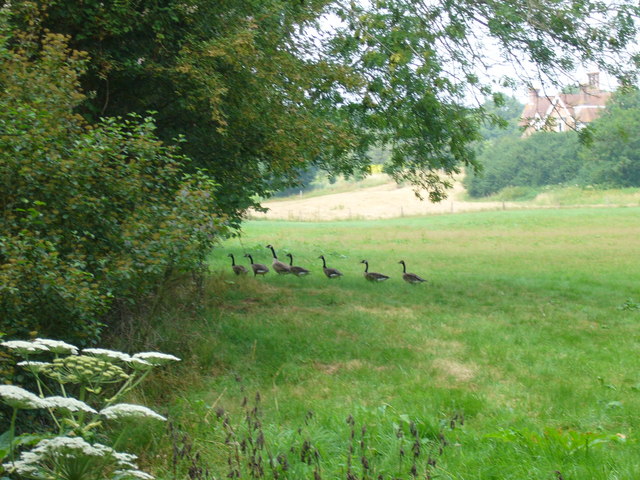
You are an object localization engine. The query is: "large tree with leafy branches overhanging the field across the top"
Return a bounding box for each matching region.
[5,0,638,215]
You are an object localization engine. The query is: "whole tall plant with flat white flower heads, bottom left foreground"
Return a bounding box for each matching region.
[0,339,179,480]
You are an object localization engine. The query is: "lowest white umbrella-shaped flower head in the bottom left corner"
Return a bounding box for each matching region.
[2,436,153,480]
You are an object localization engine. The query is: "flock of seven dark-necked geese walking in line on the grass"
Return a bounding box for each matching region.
[227,245,426,285]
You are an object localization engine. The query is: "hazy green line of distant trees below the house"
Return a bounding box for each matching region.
[465,89,640,197]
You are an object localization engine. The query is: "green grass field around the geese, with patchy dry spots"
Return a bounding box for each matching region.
[138,208,640,480]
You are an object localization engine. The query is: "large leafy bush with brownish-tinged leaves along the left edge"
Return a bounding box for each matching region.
[0,17,228,342]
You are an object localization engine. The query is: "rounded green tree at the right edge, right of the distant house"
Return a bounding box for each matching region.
[584,88,640,187]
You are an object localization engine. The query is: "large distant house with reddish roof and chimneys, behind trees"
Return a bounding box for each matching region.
[520,72,611,137]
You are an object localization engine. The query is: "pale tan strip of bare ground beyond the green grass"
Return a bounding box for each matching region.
[250,183,518,221]
